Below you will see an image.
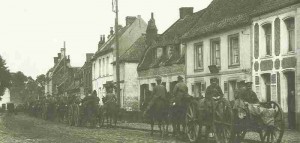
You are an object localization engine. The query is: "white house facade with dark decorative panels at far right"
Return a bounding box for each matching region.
[251,1,300,128]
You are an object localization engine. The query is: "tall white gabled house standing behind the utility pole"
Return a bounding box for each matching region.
[91,16,147,108]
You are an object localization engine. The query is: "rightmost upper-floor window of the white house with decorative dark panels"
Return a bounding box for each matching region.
[285,18,295,52]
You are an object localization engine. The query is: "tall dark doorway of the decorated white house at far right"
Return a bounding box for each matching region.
[284,71,296,129]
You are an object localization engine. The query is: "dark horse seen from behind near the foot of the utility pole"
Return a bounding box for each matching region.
[102,97,119,126]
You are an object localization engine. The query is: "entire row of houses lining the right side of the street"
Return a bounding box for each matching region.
[47,0,300,130]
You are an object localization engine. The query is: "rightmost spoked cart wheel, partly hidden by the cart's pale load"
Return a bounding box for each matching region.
[260,101,284,143]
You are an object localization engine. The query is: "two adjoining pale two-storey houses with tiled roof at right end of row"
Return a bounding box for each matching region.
[182,0,300,128]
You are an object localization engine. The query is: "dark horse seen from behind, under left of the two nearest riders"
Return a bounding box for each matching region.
[147,97,169,137]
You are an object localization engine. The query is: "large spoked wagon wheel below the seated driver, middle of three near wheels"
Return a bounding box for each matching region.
[213,99,233,143]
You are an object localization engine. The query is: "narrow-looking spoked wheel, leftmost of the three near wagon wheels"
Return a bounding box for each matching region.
[185,104,199,142]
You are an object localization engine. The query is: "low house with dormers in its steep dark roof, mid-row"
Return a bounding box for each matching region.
[138,7,204,110]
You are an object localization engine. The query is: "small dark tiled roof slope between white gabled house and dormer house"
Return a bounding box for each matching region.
[120,35,147,62]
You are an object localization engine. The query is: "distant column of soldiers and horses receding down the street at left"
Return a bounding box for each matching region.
[24,91,100,127]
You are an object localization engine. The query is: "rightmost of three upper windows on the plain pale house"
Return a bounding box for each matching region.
[229,34,240,65]
